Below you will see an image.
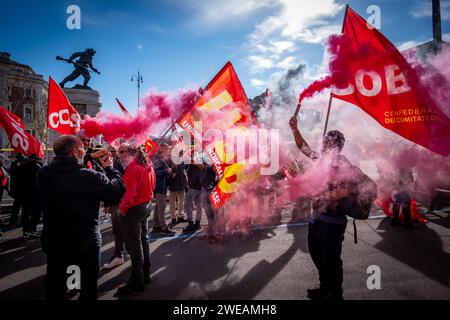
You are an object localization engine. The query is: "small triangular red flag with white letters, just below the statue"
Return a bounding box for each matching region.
[47,77,81,135]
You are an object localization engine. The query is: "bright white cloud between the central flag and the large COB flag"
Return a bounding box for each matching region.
[245,0,344,89]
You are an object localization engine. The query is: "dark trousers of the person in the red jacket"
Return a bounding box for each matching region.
[120,203,150,286]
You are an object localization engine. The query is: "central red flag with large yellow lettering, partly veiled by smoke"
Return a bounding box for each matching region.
[178,62,257,208]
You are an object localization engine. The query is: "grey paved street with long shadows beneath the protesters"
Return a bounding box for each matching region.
[0,211,450,300]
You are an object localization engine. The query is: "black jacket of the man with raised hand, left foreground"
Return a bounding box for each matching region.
[37,157,125,254]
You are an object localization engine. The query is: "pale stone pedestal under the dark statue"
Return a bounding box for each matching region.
[49,88,102,147]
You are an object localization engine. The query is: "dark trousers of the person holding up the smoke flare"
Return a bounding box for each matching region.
[308,220,347,294]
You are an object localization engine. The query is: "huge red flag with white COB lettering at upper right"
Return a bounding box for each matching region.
[333,7,450,156]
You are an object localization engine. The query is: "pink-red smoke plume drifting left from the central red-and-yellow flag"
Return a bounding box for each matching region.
[81,90,199,143]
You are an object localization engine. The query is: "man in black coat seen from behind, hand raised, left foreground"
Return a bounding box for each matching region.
[37,135,125,299]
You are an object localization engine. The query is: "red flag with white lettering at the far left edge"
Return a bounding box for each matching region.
[0,106,44,159]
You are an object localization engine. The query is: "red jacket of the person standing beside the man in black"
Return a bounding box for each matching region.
[119,160,156,215]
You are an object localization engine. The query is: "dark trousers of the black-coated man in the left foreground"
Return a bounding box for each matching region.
[44,244,100,300]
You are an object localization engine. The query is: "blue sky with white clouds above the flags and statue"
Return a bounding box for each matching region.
[0,0,450,112]
